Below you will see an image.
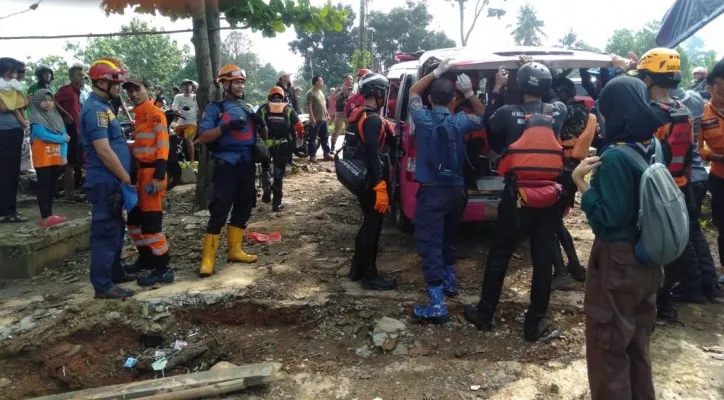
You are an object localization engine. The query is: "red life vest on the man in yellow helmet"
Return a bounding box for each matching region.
[656,101,694,187]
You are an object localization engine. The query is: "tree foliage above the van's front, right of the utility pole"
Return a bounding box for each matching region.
[367,1,456,71]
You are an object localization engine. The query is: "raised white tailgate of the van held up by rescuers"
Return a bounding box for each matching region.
[419,46,613,70]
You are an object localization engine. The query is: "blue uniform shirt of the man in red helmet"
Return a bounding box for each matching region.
[78,93,131,187]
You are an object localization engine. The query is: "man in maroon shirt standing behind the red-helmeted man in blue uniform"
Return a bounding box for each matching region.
[55,64,85,199]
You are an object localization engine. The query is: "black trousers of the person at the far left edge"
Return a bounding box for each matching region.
[0,128,24,217]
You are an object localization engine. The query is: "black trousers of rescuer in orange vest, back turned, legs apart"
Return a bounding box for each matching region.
[478,186,562,322]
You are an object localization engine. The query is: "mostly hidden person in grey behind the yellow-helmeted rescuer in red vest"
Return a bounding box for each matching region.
[672,88,722,302]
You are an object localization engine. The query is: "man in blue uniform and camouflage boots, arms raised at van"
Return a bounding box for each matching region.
[408,59,485,323]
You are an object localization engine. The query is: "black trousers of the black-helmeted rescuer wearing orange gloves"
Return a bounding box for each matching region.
[352,190,385,278]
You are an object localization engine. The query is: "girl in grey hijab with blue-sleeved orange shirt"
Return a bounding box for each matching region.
[30,89,70,228]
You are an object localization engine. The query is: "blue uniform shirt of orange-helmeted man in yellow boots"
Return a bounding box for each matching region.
[199,100,256,165]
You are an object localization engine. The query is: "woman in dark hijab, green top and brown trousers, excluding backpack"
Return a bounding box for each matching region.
[573,77,663,400]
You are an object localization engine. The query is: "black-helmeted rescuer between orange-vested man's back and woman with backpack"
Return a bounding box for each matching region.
[551,78,598,290]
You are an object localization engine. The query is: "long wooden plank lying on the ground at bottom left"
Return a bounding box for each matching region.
[36,363,282,400]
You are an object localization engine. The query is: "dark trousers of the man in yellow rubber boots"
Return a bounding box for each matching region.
[206,159,256,235]
